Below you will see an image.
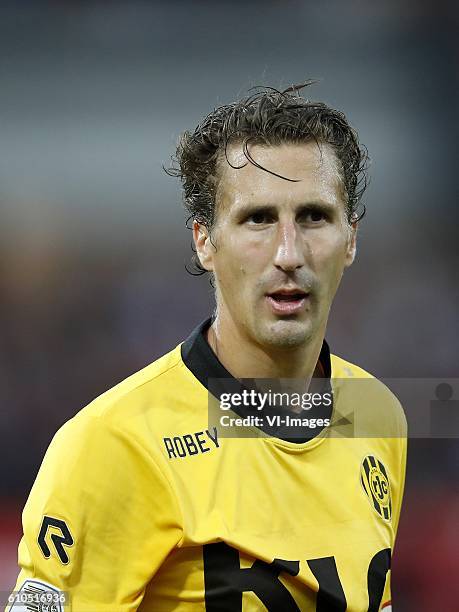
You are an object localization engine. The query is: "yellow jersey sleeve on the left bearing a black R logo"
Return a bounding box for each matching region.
[7,415,182,612]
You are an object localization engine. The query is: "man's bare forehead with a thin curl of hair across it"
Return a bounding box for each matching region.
[216,142,344,212]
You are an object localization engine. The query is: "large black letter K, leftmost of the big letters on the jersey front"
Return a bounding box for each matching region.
[203,542,300,612]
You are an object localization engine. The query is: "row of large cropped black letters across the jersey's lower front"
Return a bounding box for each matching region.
[202,542,391,612]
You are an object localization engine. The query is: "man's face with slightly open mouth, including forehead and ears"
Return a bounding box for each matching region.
[194,142,355,348]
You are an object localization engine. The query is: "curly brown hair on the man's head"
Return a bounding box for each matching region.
[166,80,369,271]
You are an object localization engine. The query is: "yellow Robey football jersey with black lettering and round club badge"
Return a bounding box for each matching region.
[7,320,406,612]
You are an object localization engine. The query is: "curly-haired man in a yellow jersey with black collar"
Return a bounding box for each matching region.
[9,87,406,612]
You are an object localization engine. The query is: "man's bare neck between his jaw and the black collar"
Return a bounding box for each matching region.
[207,313,325,382]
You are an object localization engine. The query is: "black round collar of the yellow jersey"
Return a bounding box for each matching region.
[181,318,333,443]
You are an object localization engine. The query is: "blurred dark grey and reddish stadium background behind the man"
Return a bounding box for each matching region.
[0,0,459,612]
